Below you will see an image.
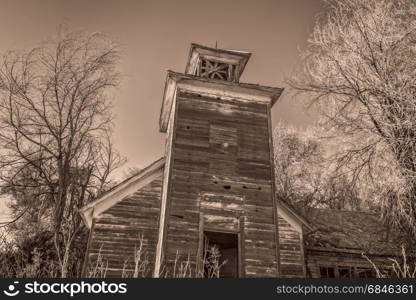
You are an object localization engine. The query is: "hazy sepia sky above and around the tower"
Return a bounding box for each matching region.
[0,0,324,180]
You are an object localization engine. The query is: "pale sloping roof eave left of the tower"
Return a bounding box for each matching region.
[80,157,165,228]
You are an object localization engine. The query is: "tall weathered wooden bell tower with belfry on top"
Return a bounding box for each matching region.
[154,44,283,277]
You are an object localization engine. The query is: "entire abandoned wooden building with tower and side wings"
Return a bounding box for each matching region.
[81,44,397,277]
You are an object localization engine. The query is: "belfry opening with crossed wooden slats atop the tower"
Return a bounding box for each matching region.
[197,59,235,81]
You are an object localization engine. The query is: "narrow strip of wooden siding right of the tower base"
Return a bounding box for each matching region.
[278,216,305,278]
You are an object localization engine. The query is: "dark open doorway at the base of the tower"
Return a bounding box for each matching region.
[203,231,238,278]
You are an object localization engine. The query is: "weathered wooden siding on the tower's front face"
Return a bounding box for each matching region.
[163,92,277,277]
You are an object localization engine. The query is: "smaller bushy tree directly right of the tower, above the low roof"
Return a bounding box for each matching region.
[273,123,368,210]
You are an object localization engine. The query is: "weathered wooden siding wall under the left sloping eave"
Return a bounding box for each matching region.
[86,175,162,277]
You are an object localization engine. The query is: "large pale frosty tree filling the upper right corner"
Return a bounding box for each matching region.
[289,0,416,234]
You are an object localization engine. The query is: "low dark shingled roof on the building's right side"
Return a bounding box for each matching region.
[303,208,400,255]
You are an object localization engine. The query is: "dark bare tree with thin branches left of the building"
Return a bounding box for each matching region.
[0,32,123,276]
